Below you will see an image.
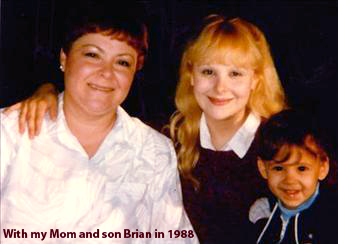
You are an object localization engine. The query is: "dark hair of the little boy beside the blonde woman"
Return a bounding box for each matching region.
[257,109,324,162]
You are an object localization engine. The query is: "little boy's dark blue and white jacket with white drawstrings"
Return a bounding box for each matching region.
[249,189,338,244]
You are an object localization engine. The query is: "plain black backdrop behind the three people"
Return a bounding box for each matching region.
[0,0,338,158]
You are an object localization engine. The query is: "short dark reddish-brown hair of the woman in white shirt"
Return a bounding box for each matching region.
[61,11,148,69]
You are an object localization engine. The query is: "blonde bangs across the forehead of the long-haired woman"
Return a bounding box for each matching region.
[191,24,262,69]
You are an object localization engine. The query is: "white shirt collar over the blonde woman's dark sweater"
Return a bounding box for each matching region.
[200,113,261,158]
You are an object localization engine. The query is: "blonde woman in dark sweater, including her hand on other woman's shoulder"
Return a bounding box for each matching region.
[4,15,286,243]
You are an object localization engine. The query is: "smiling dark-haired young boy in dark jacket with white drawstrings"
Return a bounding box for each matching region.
[249,110,338,243]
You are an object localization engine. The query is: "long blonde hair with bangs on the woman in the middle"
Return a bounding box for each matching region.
[169,15,286,186]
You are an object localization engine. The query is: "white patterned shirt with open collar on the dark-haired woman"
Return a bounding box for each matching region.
[1,94,198,244]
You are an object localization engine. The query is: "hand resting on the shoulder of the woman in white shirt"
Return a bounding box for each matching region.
[4,83,58,139]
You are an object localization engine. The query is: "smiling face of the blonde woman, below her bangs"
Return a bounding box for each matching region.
[191,63,257,122]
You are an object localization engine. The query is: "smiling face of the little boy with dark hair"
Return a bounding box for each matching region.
[258,141,329,209]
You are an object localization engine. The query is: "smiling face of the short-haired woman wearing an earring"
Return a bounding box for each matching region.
[60,33,138,118]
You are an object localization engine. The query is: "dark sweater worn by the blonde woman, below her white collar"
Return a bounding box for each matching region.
[181,138,268,244]
